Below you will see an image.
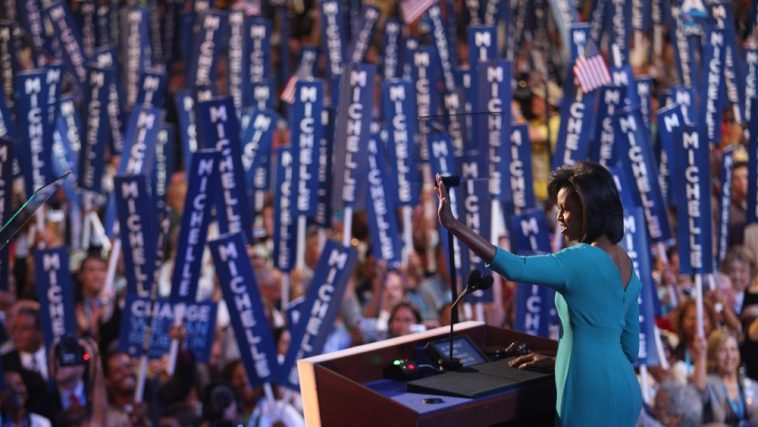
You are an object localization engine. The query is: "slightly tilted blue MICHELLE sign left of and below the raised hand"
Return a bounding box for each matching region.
[367,137,402,267]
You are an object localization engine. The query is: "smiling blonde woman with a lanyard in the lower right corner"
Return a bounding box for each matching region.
[692,329,758,427]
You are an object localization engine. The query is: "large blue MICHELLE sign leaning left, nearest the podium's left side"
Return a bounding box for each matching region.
[208,233,280,387]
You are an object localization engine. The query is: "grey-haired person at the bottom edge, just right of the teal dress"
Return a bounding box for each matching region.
[637,381,703,427]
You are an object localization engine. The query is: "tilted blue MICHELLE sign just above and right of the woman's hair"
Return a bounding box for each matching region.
[613,107,671,243]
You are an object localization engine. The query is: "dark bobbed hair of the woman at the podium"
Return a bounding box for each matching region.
[547,161,624,244]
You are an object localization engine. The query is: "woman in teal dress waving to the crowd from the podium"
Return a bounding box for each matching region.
[435,162,642,427]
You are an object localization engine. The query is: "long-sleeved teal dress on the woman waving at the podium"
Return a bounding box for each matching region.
[490,243,642,427]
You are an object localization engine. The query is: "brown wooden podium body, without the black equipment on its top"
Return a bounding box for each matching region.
[297,322,557,427]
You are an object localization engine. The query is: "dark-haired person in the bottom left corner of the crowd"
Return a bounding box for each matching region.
[0,368,52,427]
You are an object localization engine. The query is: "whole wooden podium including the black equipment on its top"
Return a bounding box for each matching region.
[298,322,557,426]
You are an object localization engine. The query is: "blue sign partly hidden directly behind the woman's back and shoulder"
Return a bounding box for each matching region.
[619,205,659,366]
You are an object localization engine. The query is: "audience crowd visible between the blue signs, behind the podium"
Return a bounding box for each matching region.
[0,1,758,426]
